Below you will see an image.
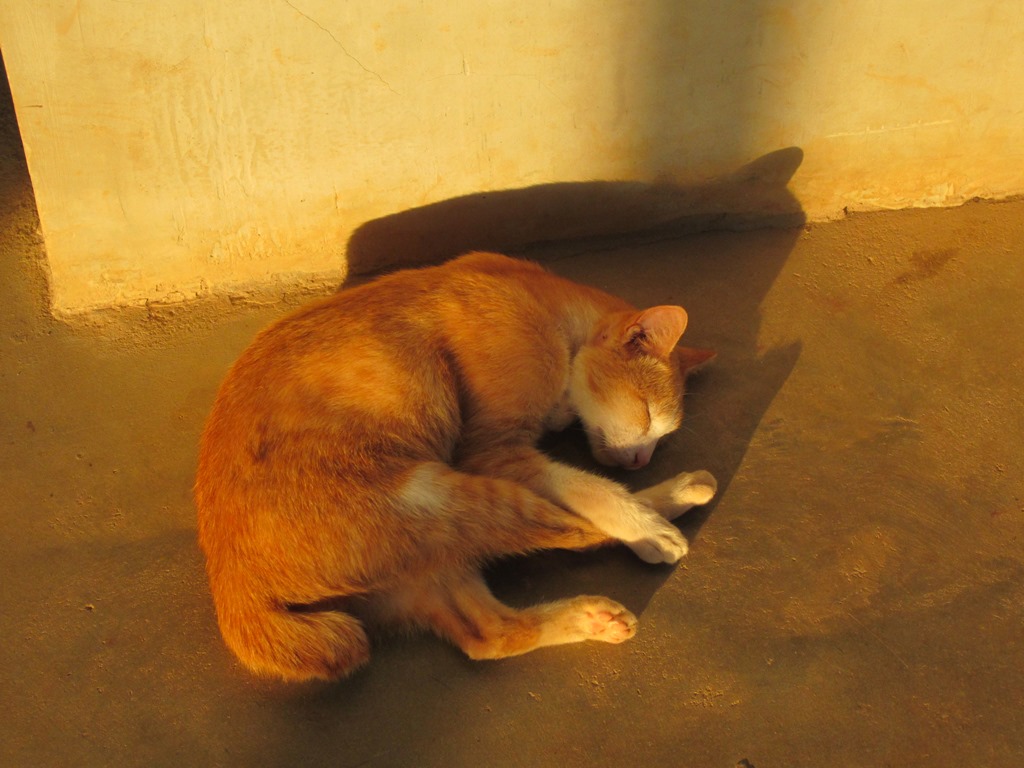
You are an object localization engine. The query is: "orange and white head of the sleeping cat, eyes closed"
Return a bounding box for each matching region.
[569,306,715,469]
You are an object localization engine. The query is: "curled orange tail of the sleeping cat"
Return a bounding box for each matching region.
[217,595,370,682]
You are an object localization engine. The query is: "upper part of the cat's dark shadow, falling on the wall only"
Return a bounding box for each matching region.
[347,146,805,276]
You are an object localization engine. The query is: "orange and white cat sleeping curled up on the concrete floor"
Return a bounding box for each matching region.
[196,253,716,680]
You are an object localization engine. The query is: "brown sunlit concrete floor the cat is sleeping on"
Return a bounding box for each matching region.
[0,81,1024,768]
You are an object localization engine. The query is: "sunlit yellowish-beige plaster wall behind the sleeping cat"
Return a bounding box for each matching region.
[0,0,1024,313]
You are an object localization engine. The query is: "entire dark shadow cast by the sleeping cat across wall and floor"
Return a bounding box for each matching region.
[346,147,805,655]
